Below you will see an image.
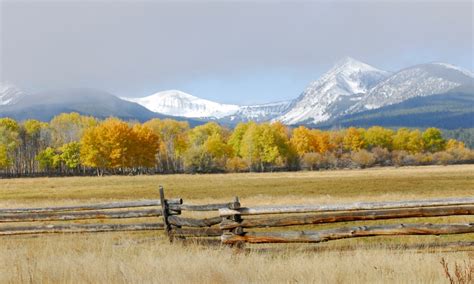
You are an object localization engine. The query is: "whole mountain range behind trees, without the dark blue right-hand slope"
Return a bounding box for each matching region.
[0,57,474,129]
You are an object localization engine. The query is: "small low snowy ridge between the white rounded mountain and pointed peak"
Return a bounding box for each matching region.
[223,101,292,122]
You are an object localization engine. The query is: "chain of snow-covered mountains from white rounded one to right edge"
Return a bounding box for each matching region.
[117,57,473,125]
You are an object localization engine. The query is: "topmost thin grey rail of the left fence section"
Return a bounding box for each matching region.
[0,199,183,214]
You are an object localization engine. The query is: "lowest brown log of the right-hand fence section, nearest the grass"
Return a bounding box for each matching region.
[221,223,474,244]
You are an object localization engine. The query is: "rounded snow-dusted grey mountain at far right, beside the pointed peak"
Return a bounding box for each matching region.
[347,63,474,113]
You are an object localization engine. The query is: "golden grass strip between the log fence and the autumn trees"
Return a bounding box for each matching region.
[0,165,474,207]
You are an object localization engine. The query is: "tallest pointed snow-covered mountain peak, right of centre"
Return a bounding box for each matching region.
[276,57,390,124]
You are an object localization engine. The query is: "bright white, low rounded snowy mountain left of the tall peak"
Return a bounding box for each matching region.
[123,90,240,118]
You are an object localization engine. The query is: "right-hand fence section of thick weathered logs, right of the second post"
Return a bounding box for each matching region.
[219,197,474,245]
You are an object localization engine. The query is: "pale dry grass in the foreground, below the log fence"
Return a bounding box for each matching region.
[0,233,473,283]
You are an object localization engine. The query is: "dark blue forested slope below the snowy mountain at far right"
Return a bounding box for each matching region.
[315,87,474,129]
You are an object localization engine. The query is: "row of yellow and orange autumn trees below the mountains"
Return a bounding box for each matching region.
[0,113,474,176]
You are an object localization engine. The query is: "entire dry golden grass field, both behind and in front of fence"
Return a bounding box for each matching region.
[0,165,474,283]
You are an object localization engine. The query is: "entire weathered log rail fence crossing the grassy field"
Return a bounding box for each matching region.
[0,187,474,245]
